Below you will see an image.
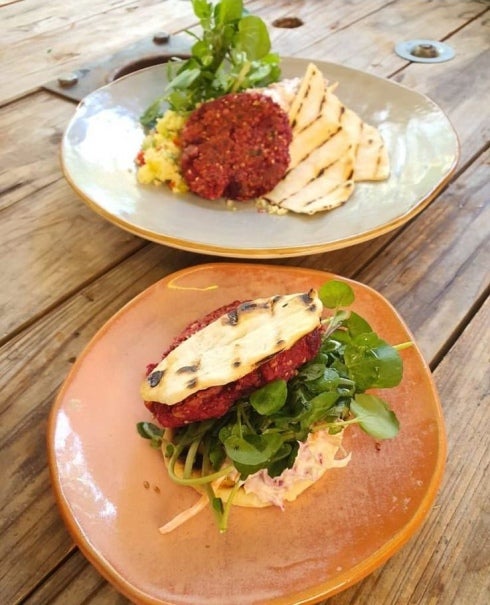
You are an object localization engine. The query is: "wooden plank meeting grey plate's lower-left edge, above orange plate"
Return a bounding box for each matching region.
[0,175,145,340]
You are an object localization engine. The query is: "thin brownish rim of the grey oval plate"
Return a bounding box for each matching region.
[59,56,461,260]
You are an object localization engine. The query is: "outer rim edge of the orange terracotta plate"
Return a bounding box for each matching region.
[46,262,447,605]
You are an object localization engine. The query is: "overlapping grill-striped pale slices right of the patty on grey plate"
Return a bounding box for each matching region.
[264,64,389,214]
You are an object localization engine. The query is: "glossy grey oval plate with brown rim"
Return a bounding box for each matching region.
[61,59,459,258]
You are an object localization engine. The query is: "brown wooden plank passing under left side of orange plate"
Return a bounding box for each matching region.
[0,246,205,603]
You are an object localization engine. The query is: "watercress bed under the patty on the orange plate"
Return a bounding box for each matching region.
[138,280,409,531]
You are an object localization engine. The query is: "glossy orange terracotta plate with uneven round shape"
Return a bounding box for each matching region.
[48,263,446,605]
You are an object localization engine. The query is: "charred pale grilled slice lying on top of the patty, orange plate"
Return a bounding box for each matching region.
[140,290,323,405]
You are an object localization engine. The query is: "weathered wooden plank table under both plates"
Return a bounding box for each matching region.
[0,0,490,605]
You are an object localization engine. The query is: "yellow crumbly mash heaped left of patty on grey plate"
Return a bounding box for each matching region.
[137,110,188,193]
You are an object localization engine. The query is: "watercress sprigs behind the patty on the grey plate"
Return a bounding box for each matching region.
[140,0,281,128]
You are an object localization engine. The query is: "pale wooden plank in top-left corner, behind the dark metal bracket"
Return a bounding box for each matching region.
[0,0,196,103]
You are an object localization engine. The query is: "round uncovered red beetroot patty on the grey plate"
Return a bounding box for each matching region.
[181,92,292,200]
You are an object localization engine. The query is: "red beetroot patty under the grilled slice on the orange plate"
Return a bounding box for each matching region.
[145,302,322,428]
